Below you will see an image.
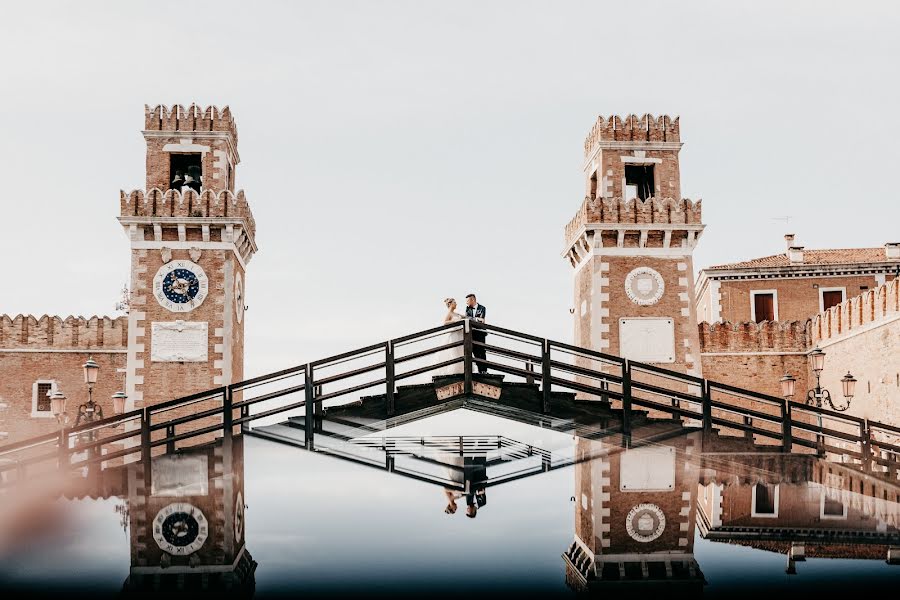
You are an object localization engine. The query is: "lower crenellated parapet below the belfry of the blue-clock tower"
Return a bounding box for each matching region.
[119,188,256,238]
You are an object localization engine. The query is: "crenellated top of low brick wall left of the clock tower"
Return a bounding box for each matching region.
[0,315,128,351]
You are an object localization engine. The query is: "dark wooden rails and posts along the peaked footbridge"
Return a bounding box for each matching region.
[0,319,900,488]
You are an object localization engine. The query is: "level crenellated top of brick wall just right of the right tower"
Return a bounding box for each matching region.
[698,321,809,354]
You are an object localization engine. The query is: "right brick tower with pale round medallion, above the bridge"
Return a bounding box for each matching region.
[563,115,704,375]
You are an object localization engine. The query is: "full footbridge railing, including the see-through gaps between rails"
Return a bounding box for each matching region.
[0,319,900,486]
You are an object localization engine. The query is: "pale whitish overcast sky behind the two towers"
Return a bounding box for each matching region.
[0,0,900,376]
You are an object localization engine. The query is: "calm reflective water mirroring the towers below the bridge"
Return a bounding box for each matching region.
[0,410,900,597]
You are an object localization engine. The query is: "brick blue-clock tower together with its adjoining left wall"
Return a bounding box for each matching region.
[0,105,256,443]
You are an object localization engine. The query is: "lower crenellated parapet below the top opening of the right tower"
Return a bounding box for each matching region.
[565,198,703,244]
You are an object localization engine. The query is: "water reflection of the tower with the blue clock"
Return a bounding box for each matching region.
[125,437,256,595]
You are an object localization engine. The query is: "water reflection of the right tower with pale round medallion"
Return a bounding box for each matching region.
[563,433,704,592]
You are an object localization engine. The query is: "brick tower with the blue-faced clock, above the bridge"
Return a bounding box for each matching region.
[119,105,256,408]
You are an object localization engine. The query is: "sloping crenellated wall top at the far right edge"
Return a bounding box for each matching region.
[808,279,900,344]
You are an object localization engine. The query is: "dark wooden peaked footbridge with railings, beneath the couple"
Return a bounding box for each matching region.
[0,320,900,484]
